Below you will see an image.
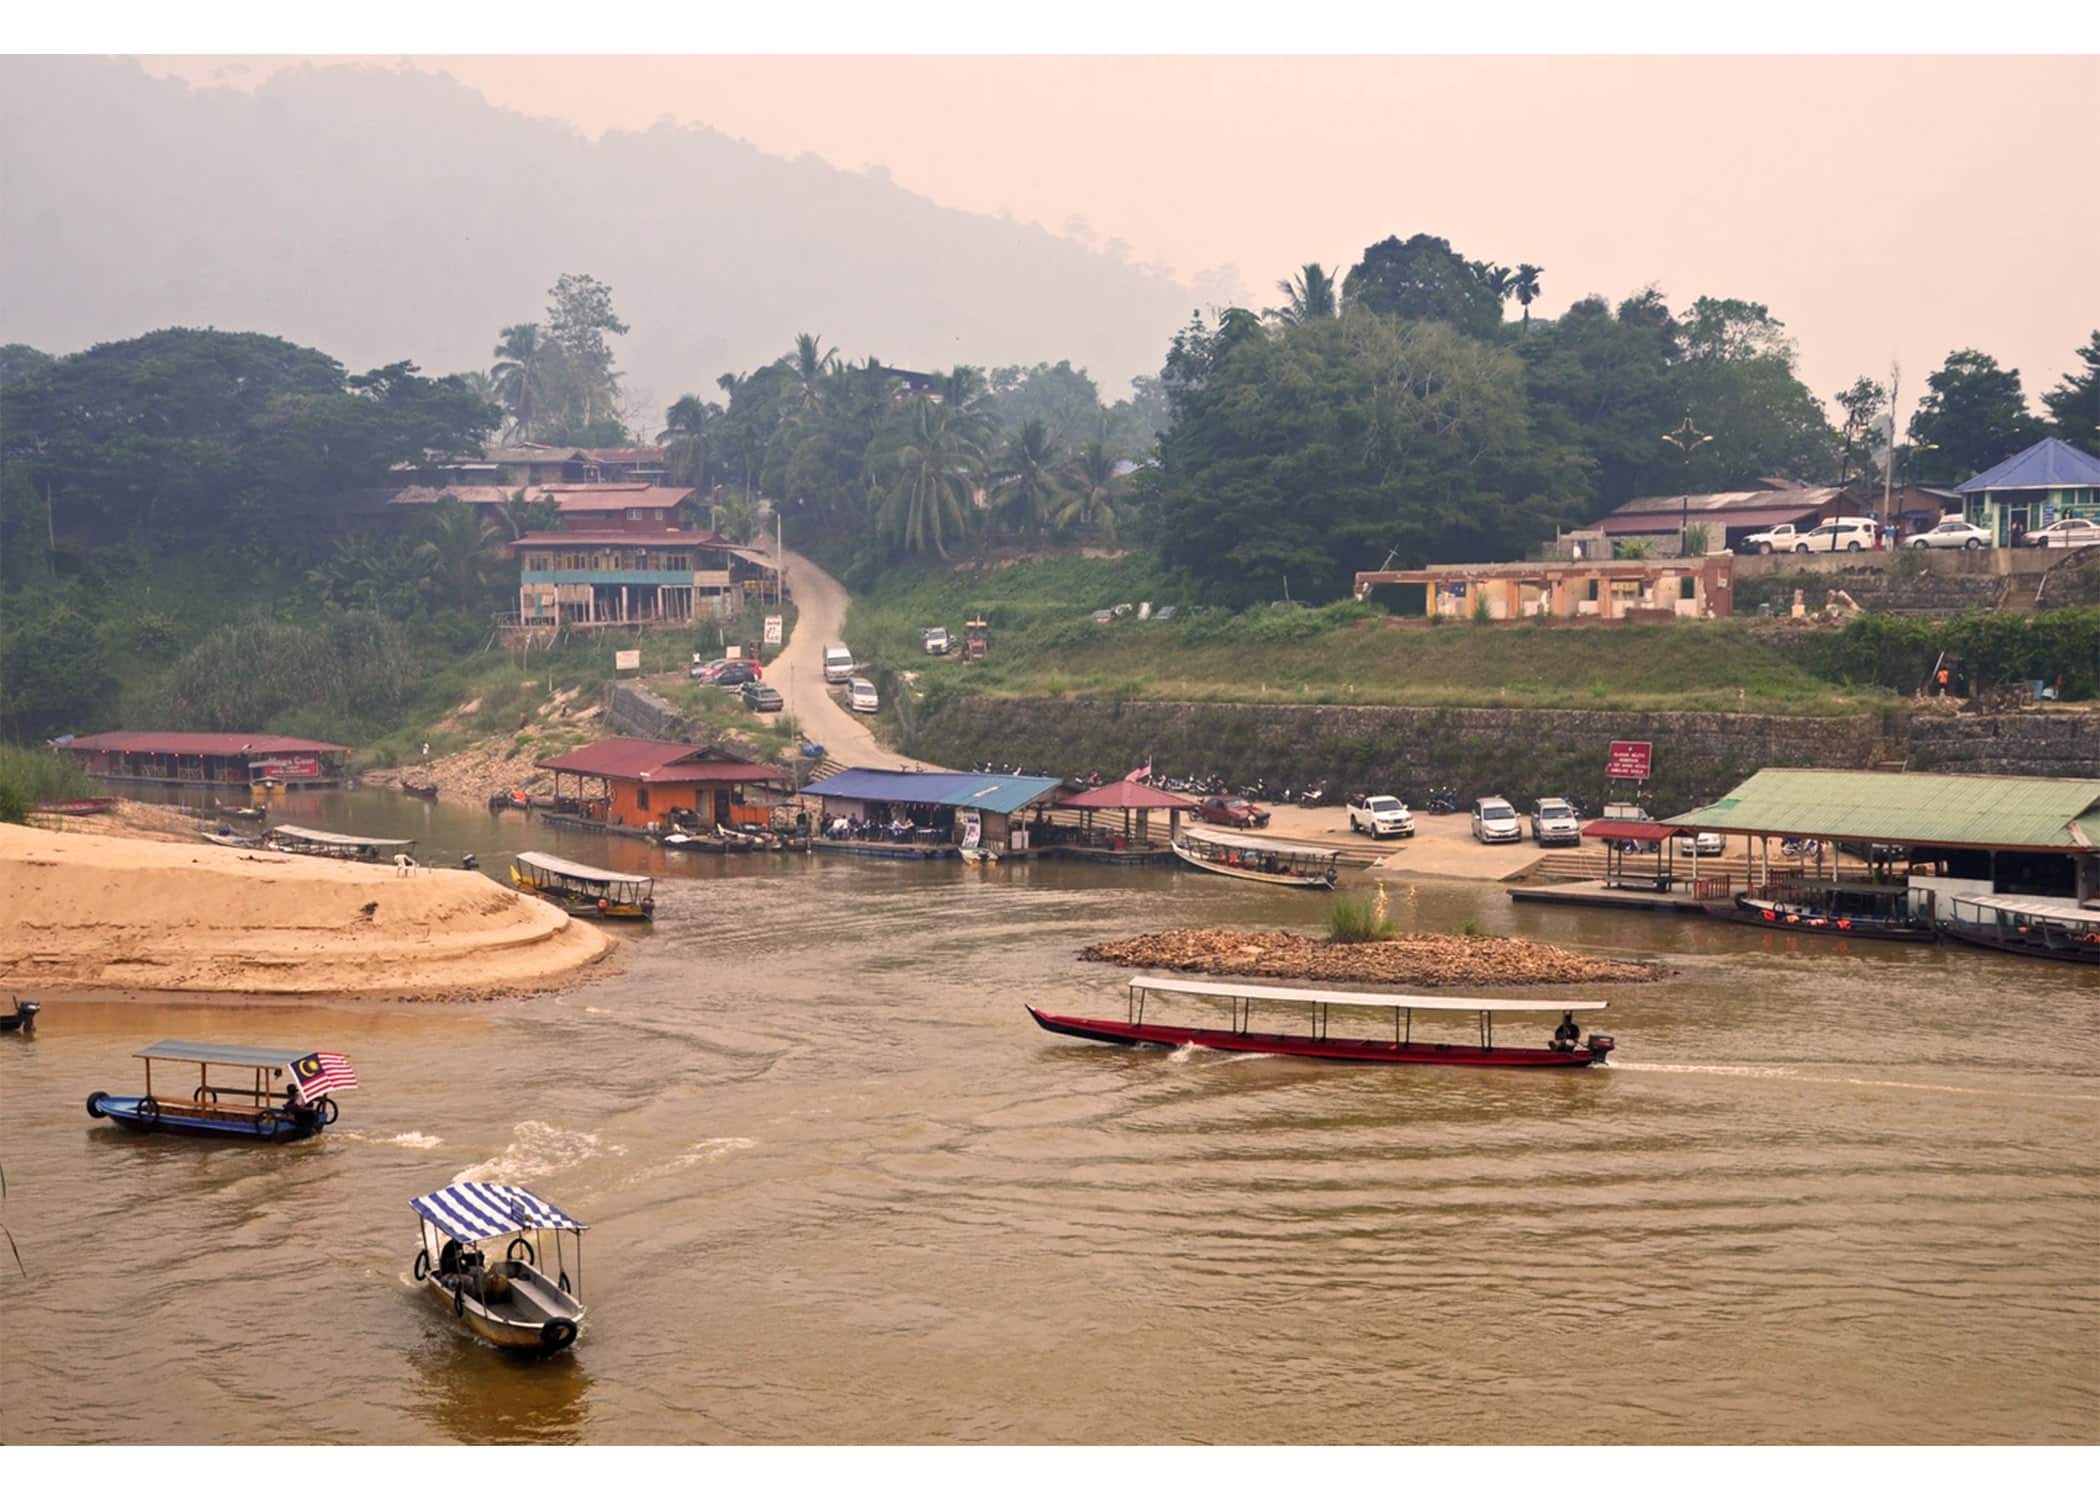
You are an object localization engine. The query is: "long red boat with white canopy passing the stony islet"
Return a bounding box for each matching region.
[1027,975,1617,1067]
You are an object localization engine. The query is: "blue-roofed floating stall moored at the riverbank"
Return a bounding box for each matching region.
[802,769,1065,859]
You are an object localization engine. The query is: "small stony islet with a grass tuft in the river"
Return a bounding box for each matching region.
[1079,926,1663,987]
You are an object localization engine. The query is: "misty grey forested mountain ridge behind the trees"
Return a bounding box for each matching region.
[0,57,1201,405]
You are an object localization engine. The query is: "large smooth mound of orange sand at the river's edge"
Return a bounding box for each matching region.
[0,826,611,1000]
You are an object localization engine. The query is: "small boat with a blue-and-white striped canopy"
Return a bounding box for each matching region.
[410,1183,590,1355]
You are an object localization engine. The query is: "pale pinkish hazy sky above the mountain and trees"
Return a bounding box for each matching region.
[147,57,2100,418]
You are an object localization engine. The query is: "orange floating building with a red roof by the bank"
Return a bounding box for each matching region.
[533,739,790,834]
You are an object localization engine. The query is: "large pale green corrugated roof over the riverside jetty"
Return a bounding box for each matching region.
[1667,771,2100,849]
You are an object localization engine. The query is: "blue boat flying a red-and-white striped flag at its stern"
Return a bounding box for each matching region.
[88,1042,357,1143]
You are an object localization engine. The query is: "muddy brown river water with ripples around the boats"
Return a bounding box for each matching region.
[0,792,2100,1443]
